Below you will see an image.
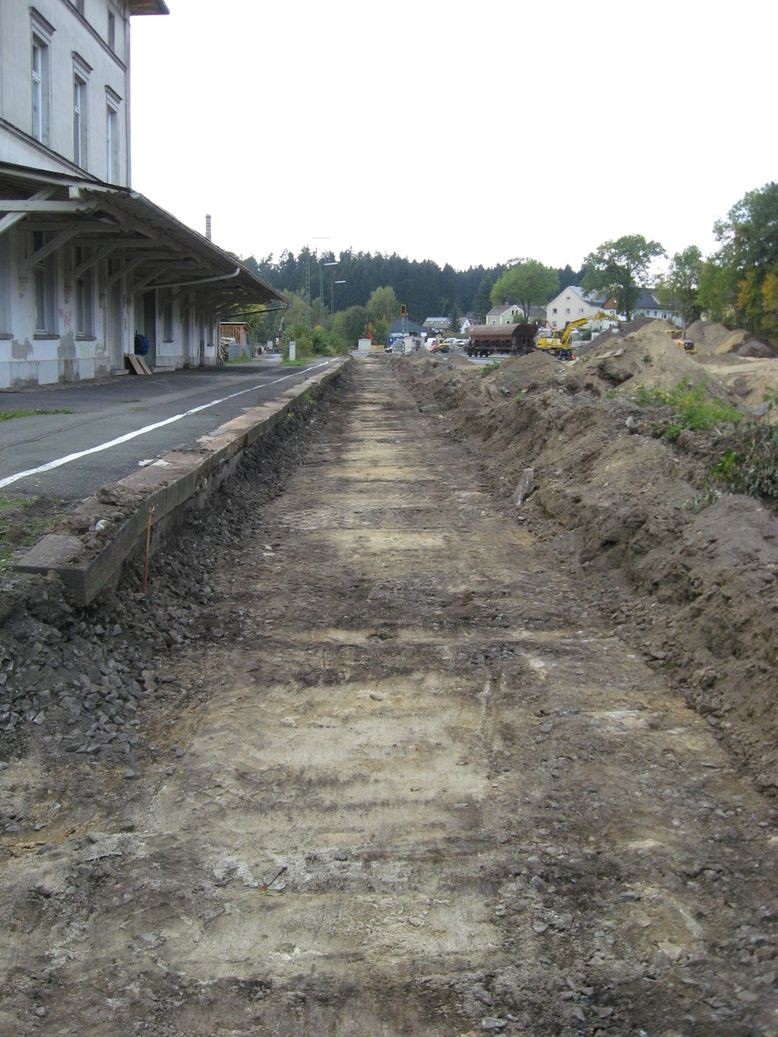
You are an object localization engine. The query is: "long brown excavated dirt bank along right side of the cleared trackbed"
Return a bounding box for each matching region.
[402,350,778,792]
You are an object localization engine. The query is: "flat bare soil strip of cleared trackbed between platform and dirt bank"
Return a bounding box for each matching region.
[0,357,778,1037]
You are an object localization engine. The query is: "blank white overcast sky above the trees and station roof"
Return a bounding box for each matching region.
[132,0,778,270]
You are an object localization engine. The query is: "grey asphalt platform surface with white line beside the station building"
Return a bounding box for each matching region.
[0,357,331,500]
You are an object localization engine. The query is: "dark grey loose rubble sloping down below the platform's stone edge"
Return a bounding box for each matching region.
[0,381,340,783]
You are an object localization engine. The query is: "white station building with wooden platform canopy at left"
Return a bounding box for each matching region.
[0,0,282,389]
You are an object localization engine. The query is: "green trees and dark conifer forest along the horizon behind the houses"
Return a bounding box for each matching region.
[244,183,778,354]
